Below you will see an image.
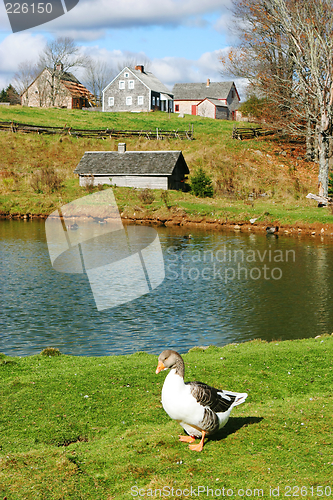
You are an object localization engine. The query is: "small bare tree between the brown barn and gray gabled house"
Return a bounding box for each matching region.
[83,58,116,106]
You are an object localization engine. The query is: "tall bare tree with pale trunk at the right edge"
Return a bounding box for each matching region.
[222,0,333,196]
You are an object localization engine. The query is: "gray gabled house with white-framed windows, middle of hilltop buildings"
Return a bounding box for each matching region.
[103,66,173,112]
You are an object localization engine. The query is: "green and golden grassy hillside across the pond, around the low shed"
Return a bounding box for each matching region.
[0,107,333,229]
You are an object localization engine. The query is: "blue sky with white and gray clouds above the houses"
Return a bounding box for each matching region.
[0,0,243,93]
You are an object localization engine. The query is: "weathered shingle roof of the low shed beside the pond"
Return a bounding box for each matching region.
[74,151,189,175]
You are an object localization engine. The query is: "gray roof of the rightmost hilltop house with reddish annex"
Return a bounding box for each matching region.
[172,82,234,100]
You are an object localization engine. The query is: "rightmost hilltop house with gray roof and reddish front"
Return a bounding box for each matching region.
[172,79,240,120]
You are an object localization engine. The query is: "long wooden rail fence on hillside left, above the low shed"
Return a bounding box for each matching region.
[0,118,193,140]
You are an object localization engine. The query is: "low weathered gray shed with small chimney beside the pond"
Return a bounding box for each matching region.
[74,143,190,190]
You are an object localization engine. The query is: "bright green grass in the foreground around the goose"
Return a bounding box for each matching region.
[0,336,333,500]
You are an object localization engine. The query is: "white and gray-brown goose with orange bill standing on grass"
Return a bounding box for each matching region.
[156,349,247,451]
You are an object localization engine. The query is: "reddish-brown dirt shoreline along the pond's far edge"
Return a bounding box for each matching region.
[0,214,333,238]
